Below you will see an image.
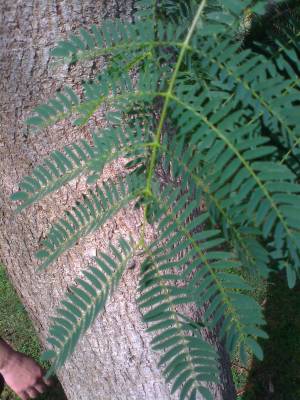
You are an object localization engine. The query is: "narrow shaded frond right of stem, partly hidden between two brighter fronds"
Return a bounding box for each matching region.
[162,138,269,277]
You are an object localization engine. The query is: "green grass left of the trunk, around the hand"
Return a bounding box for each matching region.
[0,265,66,400]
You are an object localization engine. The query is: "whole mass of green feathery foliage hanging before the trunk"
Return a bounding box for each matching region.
[12,0,300,399]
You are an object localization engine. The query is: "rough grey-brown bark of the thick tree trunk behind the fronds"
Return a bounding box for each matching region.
[0,0,235,400]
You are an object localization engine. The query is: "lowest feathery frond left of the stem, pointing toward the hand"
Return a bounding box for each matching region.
[42,239,133,377]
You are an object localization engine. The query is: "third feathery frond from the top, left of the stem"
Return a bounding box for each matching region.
[11,124,150,212]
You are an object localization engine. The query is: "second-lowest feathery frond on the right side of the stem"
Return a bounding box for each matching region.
[151,188,266,358]
